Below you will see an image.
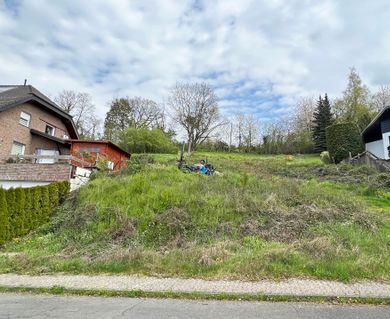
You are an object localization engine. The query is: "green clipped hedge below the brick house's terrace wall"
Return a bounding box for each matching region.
[0,181,69,245]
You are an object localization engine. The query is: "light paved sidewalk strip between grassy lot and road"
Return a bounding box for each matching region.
[0,274,390,298]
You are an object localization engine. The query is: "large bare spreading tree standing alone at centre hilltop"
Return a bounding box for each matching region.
[168,83,224,153]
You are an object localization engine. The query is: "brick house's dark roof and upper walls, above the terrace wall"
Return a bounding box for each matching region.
[0,85,78,163]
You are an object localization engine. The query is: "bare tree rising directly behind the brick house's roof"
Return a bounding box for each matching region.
[54,90,101,139]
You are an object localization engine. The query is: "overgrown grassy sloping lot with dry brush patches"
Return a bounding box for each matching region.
[0,153,390,281]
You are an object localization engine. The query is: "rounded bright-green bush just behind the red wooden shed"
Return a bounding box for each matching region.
[119,128,177,153]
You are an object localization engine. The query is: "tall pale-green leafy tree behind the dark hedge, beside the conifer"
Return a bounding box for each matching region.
[334,68,374,131]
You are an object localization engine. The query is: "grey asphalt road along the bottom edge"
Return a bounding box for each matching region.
[0,294,390,319]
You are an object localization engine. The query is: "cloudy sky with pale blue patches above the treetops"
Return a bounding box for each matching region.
[0,0,390,122]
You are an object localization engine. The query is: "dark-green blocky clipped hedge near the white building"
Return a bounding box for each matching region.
[326,123,364,163]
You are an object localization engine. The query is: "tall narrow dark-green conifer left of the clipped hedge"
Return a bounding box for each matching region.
[313,94,333,153]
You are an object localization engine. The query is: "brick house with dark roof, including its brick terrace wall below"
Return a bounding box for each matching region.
[0,85,78,188]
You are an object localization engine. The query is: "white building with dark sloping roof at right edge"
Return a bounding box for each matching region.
[362,106,390,160]
